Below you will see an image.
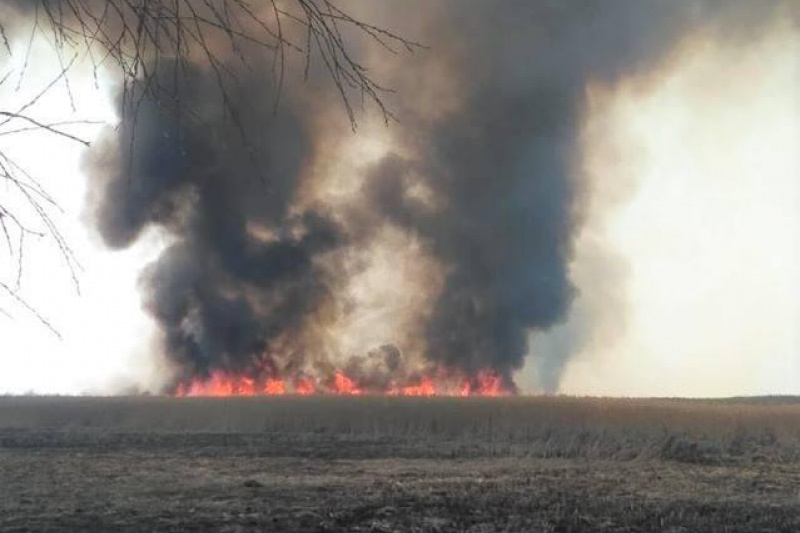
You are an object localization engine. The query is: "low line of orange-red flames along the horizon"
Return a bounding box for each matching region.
[175,370,511,397]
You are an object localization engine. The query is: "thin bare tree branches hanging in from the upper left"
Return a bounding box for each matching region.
[0,0,421,332]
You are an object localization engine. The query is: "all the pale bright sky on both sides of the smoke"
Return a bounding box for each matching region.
[0,3,800,397]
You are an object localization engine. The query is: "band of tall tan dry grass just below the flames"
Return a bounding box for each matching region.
[0,397,800,464]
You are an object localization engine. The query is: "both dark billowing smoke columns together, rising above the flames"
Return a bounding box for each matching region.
[9,0,791,390]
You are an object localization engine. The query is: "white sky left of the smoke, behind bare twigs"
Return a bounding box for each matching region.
[0,43,166,394]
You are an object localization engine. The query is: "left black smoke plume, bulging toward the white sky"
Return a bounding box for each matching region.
[89,61,343,375]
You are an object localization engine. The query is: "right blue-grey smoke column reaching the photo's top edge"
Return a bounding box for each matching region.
[352,0,785,391]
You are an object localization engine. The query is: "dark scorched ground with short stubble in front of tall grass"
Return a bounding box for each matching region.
[0,396,800,533]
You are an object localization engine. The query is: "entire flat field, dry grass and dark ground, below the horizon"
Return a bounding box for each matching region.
[0,397,800,533]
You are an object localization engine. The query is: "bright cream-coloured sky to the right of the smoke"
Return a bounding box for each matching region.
[532,18,800,396]
